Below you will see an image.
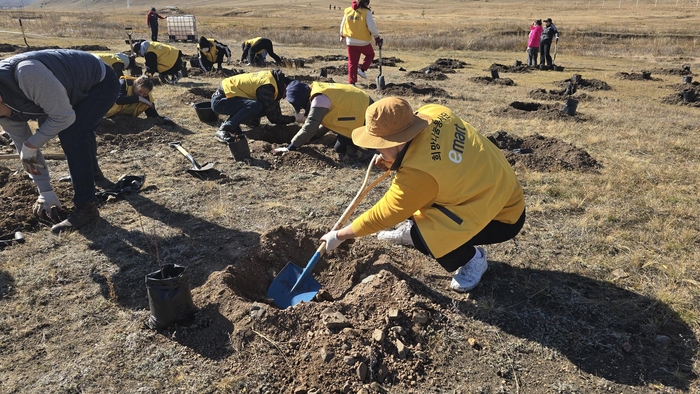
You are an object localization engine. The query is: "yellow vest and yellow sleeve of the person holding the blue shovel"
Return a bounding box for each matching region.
[352,104,525,258]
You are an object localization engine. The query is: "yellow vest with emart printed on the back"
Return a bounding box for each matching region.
[398,104,525,258]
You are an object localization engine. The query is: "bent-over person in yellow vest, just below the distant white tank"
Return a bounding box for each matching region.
[132,41,182,83]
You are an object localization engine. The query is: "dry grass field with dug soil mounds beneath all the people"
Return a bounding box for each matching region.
[0,0,700,394]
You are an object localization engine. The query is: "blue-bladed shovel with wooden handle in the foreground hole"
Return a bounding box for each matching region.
[267,155,390,309]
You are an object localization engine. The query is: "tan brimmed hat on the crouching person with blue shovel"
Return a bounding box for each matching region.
[352,97,432,149]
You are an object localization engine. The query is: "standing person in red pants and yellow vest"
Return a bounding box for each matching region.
[340,0,381,85]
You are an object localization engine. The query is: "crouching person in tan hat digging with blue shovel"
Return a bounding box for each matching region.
[321,97,525,292]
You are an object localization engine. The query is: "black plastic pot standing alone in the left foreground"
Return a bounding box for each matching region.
[146,264,197,330]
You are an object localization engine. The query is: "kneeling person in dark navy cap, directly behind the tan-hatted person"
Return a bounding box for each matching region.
[273,81,374,154]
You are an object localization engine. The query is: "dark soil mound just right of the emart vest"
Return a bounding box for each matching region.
[488,131,601,172]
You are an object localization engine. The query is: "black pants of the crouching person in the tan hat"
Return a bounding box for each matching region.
[411,210,525,272]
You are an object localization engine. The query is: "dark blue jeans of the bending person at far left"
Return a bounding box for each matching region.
[58,67,119,206]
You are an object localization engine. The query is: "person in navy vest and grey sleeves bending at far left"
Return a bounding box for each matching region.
[0,49,119,233]
